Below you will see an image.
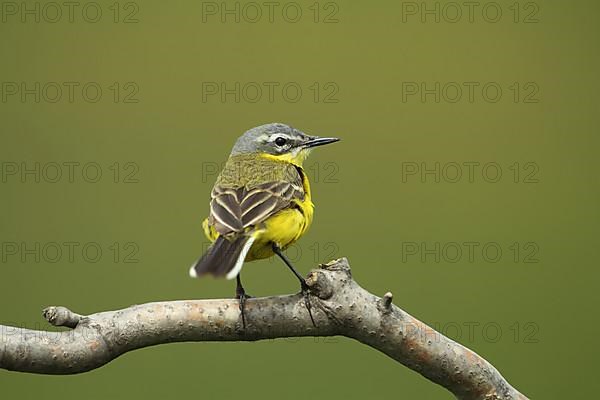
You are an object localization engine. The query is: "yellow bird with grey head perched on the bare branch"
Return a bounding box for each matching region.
[189,123,340,328]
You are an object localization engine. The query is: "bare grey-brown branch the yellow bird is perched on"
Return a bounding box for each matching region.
[0,258,526,400]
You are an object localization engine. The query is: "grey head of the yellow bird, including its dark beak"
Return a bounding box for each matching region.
[231,122,339,156]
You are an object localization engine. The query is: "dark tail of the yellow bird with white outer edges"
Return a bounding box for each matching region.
[190,236,254,279]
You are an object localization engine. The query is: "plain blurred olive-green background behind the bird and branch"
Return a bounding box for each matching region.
[0,1,600,399]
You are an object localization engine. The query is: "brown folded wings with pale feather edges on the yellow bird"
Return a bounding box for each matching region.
[209,181,304,235]
